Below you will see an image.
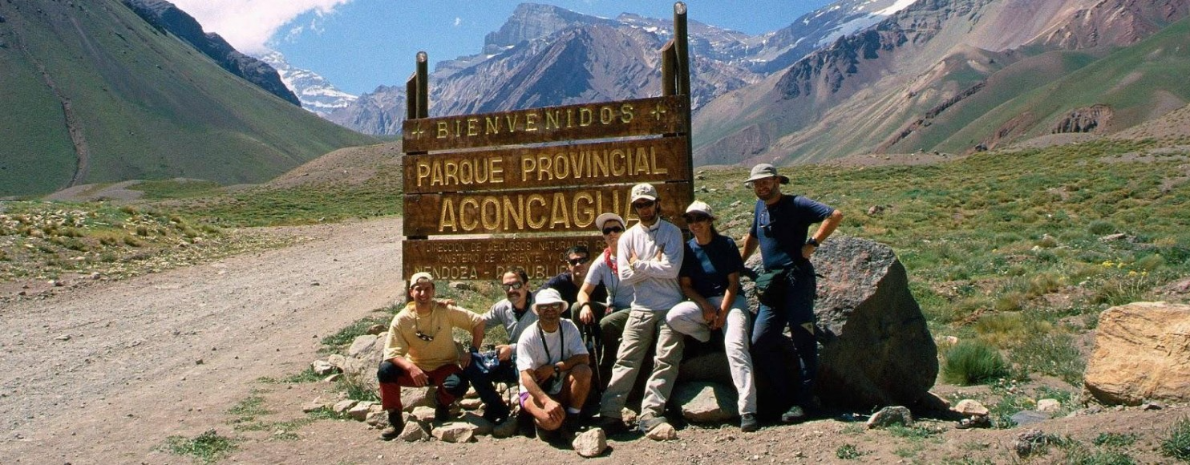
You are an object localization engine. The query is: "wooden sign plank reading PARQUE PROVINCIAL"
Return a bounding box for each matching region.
[405,137,690,194]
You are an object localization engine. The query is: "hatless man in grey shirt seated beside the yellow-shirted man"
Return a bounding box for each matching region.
[463,266,537,423]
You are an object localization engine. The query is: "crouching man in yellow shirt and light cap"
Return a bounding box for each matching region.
[376,272,483,440]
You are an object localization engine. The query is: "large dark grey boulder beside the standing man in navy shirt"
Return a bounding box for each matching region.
[745,235,938,409]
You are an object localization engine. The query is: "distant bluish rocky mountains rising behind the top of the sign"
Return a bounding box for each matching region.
[327,0,908,134]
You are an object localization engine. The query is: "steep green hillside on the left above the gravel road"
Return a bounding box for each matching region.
[0,0,375,196]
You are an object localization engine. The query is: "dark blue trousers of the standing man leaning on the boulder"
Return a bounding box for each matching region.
[752,264,818,408]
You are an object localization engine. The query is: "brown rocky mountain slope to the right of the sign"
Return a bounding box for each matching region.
[694,0,1190,163]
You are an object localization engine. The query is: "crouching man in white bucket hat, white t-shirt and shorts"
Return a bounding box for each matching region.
[516,289,591,442]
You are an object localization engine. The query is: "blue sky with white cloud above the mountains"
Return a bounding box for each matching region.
[173,0,831,94]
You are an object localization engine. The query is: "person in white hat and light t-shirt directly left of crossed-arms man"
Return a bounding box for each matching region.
[570,213,633,390]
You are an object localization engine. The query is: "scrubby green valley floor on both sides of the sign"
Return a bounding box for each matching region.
[0,138,1190,385]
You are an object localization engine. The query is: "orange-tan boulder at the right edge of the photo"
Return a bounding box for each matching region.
[1083,302,1190,406]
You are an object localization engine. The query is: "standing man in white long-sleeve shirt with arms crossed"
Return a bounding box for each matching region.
[600,183,684,440]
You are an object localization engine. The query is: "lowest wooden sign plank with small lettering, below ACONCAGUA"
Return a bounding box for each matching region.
[401,235,607,283]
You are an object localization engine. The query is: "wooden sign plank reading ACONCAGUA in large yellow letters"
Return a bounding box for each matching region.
[405,182,694,237]
